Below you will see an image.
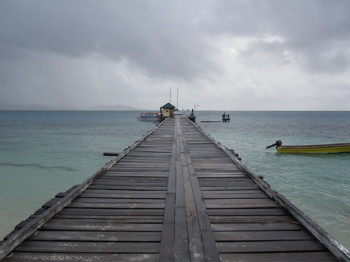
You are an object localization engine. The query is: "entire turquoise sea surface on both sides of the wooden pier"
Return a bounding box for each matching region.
[0,111,350,249]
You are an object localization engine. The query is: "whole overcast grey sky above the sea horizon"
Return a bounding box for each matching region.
[0,0,350,110]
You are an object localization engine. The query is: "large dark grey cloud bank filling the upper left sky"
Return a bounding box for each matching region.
[0,1,219,79]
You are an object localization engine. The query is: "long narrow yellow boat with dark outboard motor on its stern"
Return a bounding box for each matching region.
[266,140,350,154]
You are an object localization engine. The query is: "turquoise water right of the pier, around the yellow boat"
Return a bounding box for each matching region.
[198,112,350,249]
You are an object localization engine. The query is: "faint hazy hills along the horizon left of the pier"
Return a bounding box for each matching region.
[0,103,141,111]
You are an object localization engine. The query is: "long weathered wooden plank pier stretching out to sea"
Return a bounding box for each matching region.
[0,118,350,262]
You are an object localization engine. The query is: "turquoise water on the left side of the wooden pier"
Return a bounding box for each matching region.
[0,111,154,239]
